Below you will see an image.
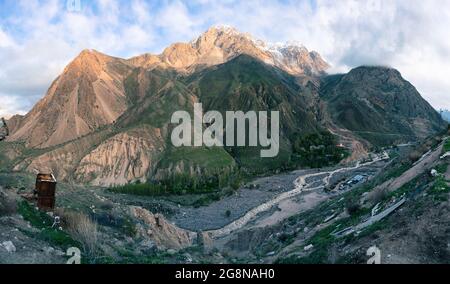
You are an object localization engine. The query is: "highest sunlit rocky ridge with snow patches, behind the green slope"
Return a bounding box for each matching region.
[130,26,329,75]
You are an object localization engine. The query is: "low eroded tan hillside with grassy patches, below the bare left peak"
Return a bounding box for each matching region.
[10,126,166,186]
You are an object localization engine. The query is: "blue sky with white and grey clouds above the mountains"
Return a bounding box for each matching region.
[0,0,450,116]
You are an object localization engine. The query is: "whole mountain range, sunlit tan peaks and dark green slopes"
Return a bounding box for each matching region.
[0,27,447,186]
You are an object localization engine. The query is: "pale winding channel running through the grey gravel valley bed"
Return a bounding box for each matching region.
[208,157,389,238]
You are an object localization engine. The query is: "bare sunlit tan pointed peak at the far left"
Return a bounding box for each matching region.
[9,50,131,148]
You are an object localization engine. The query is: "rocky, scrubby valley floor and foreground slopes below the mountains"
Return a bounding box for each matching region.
[0,140,450,263]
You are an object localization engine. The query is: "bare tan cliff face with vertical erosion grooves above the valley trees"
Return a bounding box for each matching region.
[75,127,165,186]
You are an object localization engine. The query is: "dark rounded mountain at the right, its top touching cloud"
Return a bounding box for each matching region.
[321,67,446,145]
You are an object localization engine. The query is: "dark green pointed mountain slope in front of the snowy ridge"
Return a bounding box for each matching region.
[186,55,320,172]
